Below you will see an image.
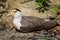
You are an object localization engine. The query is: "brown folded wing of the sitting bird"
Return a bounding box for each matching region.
[22,16,56,31]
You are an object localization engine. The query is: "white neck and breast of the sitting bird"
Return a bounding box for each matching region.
[13,11,22,30]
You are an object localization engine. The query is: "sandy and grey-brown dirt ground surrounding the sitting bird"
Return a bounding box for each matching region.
[0,0,60,40]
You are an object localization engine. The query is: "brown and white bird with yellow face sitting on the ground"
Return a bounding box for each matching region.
[7,8,57,32]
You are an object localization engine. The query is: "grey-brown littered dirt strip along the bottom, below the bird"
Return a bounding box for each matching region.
[0,29,60,40]
